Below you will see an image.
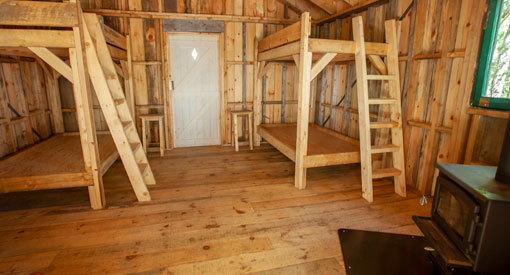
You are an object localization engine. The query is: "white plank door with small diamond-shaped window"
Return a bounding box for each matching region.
[169,34,220,147]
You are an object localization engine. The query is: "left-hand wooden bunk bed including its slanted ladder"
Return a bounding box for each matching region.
[0,0,155,209]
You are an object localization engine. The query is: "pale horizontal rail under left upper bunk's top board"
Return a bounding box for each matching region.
[0,29,74,48]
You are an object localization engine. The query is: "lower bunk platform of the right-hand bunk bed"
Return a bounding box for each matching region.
[258,123,360,168]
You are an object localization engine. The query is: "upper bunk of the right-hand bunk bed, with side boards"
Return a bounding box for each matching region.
[257,12,388,65]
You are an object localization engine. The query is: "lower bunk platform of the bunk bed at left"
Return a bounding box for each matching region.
[0,134,119,193]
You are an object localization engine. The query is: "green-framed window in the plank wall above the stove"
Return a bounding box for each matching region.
[471,0,510,110]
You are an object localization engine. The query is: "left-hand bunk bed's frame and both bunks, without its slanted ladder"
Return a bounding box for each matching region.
[0,0,138,209]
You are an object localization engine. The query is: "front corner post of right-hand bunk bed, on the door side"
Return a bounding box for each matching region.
[294,12,312,189]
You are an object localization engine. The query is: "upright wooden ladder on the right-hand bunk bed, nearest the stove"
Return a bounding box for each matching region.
[352,16,406,202]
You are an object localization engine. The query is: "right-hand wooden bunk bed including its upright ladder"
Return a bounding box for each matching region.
[254,12,405,202]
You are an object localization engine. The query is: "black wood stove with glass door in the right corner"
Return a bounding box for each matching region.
[413,164,510,274]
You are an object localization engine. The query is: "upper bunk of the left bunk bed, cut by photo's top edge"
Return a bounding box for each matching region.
[0,0,128,60]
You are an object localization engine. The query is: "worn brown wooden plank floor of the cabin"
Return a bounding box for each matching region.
[0,145,430,274]
